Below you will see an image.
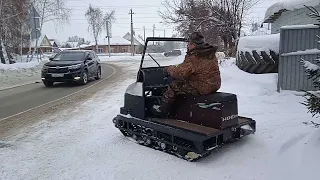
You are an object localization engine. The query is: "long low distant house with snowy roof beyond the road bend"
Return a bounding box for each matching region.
[80,37,142,54]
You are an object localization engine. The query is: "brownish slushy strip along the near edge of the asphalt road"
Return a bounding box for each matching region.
[0,63,123,139]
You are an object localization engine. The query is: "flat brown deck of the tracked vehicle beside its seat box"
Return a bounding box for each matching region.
[152,117,250,136]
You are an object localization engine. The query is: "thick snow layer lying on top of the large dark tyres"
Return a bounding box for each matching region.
[237,33,280,53]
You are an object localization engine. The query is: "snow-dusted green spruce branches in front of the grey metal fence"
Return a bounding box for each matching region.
[301,6,320,118]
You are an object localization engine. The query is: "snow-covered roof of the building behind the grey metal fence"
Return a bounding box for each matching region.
[264,0,320,23]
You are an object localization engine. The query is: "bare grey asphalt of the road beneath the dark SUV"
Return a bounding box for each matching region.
[0,64,115,120]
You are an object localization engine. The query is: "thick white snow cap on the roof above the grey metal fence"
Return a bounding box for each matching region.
[264,0,320,20]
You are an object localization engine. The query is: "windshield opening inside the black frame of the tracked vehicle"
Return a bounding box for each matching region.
[142,41,187,68]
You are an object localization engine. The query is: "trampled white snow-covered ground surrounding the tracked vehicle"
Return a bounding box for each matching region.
[0,55,320,180]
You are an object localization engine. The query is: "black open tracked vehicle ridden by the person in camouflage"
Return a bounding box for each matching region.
[113,37,256,161]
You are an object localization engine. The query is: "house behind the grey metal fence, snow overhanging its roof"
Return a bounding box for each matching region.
[263,0,320,34]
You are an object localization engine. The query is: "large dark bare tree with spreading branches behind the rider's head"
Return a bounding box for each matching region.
[159,0,259,55]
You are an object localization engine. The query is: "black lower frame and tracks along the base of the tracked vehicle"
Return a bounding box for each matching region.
[113,115,255,162]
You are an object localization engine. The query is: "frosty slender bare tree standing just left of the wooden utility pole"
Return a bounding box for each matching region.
[85,4,115,52]
